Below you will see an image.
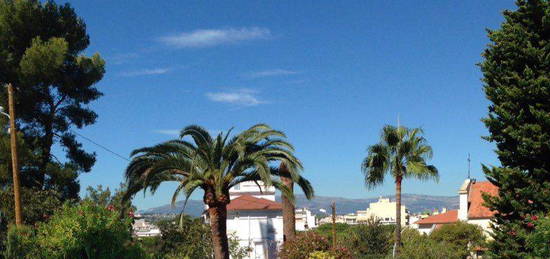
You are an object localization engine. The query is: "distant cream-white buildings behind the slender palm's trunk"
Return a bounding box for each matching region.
[357,197,409,226]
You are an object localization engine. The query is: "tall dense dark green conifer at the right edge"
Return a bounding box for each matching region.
[480,0,550,258]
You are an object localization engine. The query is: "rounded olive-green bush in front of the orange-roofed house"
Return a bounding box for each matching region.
[430,221,485,258]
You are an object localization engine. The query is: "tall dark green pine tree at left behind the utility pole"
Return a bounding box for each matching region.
[0,0,105,198]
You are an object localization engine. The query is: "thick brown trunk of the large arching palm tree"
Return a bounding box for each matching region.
[208,204,229,259]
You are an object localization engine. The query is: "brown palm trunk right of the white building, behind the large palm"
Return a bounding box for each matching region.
[279,163,296,242]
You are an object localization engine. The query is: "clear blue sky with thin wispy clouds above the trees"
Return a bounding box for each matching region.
[60,0,514,211]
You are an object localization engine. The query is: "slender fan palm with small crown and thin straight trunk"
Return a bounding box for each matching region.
[361,125,439,254]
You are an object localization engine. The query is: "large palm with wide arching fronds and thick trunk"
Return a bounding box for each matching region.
[125,124,313,259]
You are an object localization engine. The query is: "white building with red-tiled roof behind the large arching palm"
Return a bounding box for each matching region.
[227,182,283,259]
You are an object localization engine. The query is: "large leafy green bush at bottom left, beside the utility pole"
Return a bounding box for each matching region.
[2,202,145,258]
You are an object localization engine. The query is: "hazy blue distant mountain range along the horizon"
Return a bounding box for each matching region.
[139,194,458,217]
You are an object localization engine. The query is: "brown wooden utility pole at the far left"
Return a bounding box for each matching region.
[8,84,23,226]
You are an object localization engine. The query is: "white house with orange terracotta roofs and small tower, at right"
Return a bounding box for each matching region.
[414,179,498,236]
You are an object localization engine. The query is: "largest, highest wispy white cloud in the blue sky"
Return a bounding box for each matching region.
[159,27,271,48]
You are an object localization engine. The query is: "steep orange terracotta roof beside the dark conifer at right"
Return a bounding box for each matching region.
[468,181,498,219]
